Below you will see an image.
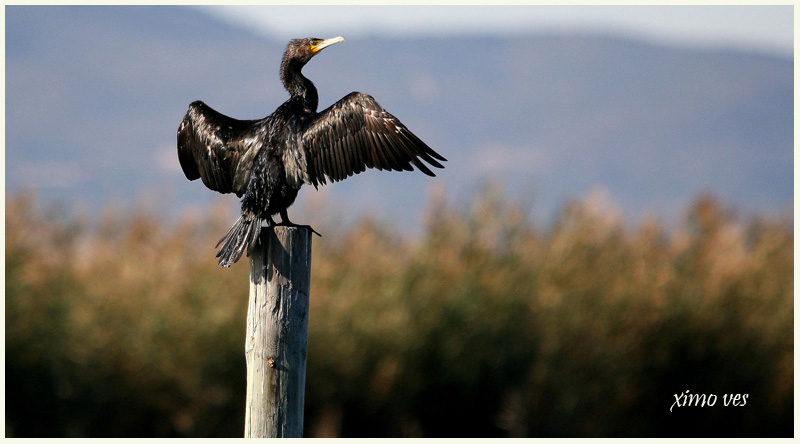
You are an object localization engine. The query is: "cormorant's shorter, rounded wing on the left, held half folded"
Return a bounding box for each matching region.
[178,101,263,196]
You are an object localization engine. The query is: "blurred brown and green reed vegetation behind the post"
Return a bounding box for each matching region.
[5,187,794,437]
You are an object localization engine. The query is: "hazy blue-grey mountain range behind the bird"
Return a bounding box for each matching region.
[5,6,794,231]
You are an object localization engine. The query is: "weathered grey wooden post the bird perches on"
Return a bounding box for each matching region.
[244,226,311,438]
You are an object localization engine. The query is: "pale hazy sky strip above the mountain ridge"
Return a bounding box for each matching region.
[202,5,794,56]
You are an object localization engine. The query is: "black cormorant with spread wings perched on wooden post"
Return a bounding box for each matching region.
[178,37,446,267]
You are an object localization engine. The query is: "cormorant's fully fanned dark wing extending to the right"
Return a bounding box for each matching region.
[300,92,447,186]
